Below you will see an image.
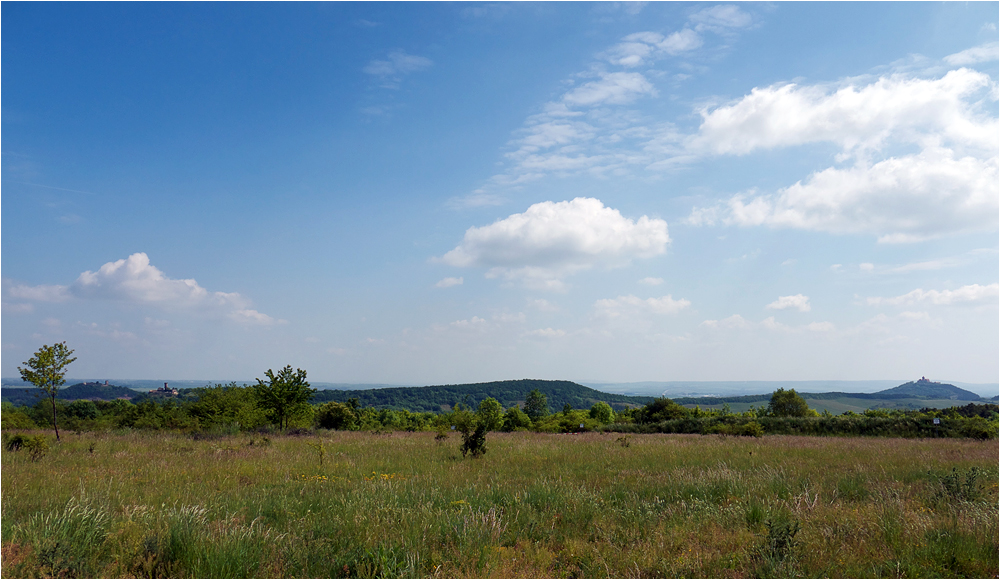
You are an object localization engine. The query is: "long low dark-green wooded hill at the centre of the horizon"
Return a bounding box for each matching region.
[312,379,653,413]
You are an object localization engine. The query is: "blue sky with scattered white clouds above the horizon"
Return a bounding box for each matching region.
[0,2,1000,384]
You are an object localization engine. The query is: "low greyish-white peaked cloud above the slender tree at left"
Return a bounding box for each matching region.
[4,252,285,324]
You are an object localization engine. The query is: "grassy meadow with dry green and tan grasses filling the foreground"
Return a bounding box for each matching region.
[0,431,998,578]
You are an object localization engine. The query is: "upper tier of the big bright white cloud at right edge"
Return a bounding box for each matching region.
[687,69,997,155]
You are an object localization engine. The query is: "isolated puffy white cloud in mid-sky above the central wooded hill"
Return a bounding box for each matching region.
[439,197,670,290]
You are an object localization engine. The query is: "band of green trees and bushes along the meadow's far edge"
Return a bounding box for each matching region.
[2,383,1000,439]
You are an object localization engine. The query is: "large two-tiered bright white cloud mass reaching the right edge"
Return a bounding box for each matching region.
[685,68,1000,243]
